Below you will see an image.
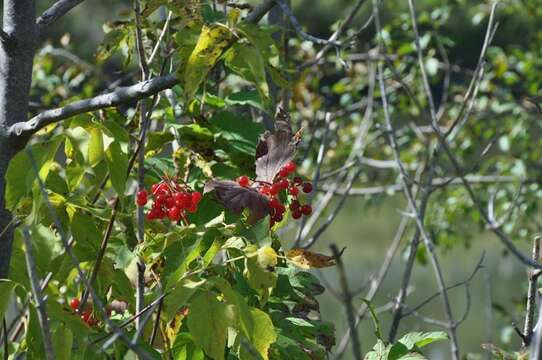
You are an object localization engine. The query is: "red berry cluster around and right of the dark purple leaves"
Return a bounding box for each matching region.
[237,161,312,226]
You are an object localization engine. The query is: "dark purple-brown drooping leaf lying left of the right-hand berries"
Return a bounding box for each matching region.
[204,180,269,224]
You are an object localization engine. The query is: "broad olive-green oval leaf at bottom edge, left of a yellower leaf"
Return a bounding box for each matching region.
[188,291,233,360]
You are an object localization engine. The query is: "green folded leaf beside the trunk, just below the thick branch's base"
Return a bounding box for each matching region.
[5,138,60,211]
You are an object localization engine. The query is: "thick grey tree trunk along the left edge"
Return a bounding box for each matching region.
[0,0,38,278]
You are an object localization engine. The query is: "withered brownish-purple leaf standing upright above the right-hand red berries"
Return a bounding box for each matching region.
[256,106,299,183]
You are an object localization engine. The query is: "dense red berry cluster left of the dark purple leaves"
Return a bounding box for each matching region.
[136,181,201,222]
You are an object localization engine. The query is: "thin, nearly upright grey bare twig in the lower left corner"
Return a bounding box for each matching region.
[23,227,56,360]
